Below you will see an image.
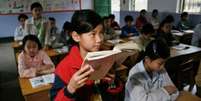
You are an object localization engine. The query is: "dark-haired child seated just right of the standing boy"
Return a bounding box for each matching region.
[47,17,62,48]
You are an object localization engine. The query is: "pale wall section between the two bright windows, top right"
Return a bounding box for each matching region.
[148,0,178,12]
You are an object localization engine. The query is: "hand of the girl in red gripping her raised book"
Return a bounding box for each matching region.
[67,64,94,94]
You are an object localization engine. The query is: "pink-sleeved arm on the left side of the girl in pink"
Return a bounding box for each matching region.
[18,54,36,78]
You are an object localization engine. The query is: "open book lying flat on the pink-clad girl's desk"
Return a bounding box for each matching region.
[29,73,55,88]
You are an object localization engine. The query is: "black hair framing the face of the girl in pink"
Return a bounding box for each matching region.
[22,34,42,50]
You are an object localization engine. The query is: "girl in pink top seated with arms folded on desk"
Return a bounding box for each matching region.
[18,35,54,78]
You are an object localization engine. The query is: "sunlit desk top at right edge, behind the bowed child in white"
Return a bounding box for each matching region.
[170,44,201,57]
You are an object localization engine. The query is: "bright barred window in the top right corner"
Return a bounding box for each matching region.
[180,0,201,13]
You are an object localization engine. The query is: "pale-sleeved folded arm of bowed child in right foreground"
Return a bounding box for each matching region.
[125,78,170,101]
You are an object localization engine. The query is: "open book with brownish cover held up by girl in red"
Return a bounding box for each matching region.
[83,43,138,80]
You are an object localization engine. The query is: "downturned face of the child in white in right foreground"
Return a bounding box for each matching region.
[147,58,165,72]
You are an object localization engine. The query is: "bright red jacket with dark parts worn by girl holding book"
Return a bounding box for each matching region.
[53,46,93,101]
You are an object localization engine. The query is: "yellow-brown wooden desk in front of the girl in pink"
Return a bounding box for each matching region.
[19,78,52,101]
